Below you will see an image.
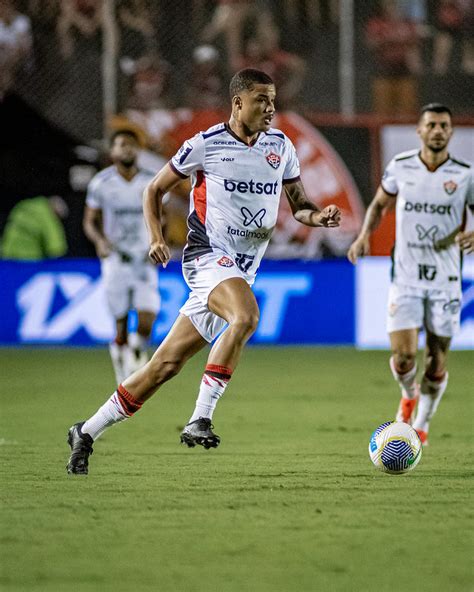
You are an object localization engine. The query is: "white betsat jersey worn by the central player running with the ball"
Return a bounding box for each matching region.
[170,123,300,275]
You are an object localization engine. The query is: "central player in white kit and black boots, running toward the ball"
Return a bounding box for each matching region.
[67,69,340,474]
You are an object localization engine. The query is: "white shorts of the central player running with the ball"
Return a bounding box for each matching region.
[179,250,255,343]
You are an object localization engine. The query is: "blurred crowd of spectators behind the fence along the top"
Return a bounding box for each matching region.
[2,0,474,141]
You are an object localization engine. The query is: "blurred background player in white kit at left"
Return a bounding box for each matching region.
[83,130,159,384]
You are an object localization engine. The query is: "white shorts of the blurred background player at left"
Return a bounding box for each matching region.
[101,253,160,319]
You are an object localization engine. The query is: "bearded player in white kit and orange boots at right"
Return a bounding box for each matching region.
[348,103,474,445]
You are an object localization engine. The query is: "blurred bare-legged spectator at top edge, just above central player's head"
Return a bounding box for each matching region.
[202,0,277,72]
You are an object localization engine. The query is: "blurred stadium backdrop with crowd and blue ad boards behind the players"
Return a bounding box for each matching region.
[0,0,474,348]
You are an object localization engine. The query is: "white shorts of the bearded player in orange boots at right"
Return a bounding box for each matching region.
[387,283,462,337]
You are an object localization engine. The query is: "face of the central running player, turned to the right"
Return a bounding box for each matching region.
[239,84,276,133]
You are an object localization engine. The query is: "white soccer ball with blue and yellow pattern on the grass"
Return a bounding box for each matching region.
[369,421,423,475]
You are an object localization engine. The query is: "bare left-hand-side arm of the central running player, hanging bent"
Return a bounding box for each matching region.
[143,164,187,267]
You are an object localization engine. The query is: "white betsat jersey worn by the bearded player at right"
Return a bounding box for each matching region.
[382,150,474,290]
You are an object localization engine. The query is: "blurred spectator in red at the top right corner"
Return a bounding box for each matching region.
[433,0,474,75]
